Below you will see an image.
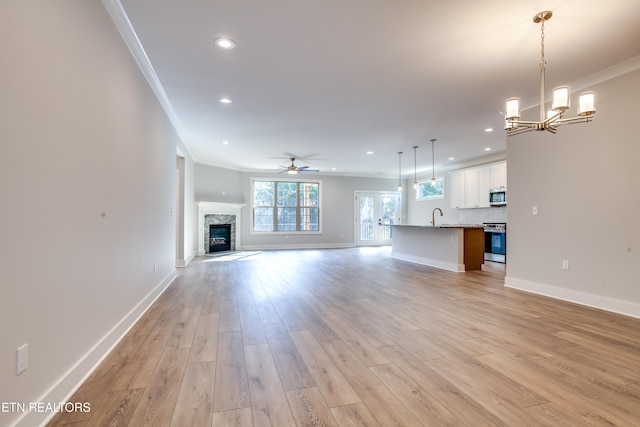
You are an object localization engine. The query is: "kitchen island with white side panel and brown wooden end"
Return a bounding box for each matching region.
[391,224,484,272]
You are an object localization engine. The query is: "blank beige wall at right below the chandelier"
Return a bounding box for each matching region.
[506,70,640,317]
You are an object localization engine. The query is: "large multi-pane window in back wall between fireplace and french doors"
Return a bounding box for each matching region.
[251,179,321,233]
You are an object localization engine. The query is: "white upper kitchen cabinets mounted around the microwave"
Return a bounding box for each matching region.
[451,162,507,209]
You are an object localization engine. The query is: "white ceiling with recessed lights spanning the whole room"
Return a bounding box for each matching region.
[112,0,640,177]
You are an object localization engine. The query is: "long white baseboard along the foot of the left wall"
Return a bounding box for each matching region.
[17,269,177,426]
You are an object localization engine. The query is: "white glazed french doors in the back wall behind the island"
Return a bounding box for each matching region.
[354,191,400,246]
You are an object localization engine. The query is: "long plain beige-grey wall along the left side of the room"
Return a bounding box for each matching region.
[0,0,193,425]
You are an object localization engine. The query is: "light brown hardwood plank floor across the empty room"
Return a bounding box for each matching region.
[50,248,640,427]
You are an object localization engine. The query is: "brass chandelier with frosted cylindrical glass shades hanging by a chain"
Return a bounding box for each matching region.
[505,10,596,136]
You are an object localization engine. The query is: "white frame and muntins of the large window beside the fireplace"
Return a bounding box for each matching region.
[249,177,324,236]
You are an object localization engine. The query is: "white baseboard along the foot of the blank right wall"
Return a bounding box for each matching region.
[504,276,640,318]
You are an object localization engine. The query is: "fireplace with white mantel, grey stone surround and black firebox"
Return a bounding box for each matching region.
[198,202,245,255]
